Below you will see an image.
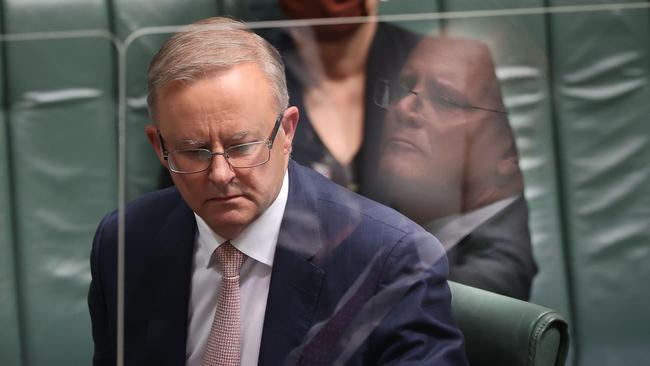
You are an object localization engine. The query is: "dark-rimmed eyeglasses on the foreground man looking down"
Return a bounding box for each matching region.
[158,113,284,174]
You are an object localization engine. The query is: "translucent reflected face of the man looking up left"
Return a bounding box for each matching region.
[380,38,502,220]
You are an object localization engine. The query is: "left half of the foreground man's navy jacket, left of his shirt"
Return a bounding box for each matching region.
[88,188,196,365]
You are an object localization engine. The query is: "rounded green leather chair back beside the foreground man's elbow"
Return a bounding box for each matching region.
[449,281,569,366]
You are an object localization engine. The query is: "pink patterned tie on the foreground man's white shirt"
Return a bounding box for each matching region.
[201,242,246,366]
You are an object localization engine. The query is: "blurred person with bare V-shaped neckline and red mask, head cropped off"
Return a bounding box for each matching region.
[270,0,419,195]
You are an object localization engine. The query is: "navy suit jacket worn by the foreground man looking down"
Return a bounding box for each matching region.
[88,162,467,365]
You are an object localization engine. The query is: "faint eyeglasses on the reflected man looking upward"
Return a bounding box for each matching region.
[373,79,508,114]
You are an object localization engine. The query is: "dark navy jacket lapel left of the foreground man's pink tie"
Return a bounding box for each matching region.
[145,201,196,365]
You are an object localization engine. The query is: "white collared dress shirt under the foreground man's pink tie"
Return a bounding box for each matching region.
[185,172,289,366]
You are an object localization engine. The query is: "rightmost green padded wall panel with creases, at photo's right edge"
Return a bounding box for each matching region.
[551,1,650,366]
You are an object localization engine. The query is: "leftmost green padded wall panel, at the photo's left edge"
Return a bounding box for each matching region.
[4,0,117,366]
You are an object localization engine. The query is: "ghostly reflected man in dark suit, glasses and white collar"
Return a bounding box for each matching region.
[377,37,537,300]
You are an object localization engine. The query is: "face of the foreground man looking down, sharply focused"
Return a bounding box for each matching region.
[146,63,298,239]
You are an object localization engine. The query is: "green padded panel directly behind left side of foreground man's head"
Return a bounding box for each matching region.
[114,0,218,200]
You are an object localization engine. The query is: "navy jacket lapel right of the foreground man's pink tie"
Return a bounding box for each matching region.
[259,161,325,365]
